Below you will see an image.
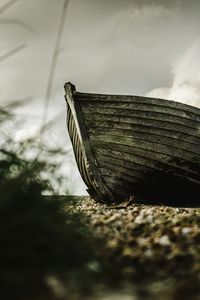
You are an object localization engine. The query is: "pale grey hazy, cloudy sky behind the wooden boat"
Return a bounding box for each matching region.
[0,0,200,194]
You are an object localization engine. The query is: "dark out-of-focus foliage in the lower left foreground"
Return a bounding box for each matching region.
[0,105,103,300]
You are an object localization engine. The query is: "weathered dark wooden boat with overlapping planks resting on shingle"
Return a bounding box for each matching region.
[65,83,200,203]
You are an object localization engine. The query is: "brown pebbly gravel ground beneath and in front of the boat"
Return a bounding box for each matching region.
[64,197,200,300]
